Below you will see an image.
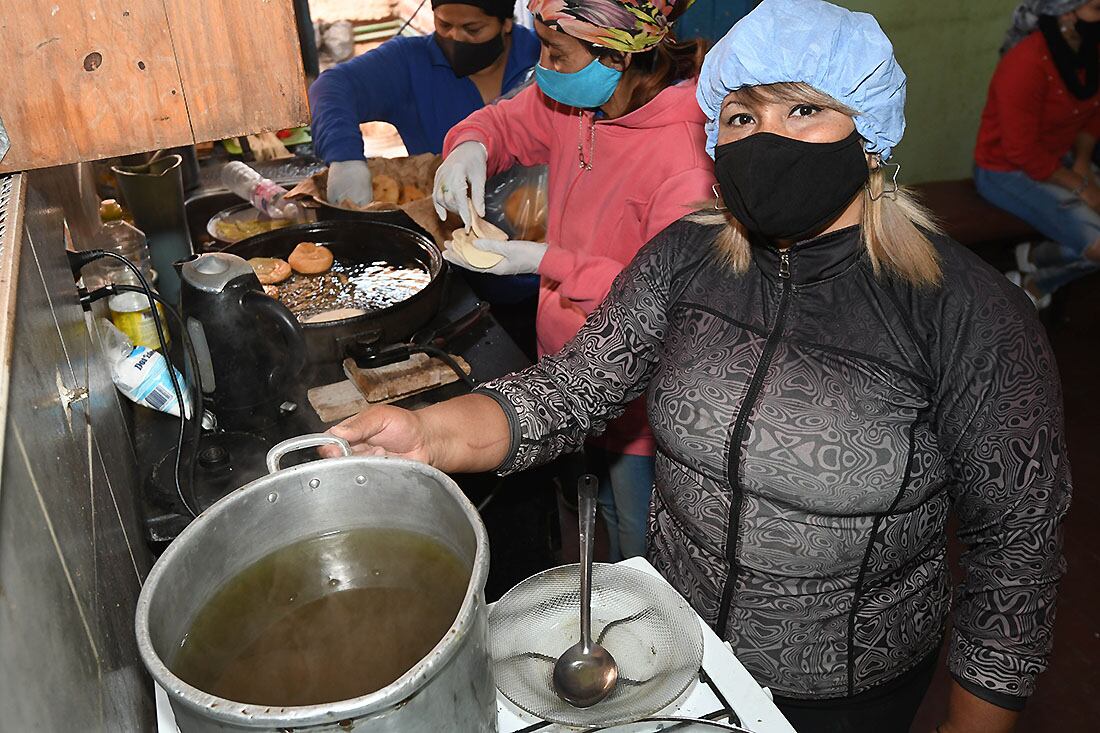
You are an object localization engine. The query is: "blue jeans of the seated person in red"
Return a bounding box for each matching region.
[974,166,1100,293]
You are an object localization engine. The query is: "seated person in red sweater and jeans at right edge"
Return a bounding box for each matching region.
[975,0,1100,308]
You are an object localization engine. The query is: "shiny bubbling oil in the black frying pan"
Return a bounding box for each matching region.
[276,259,431,320]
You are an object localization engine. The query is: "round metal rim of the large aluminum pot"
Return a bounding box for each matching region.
[134,456,488,729]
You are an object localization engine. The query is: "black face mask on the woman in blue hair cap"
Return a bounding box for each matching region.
[714,126,869,240]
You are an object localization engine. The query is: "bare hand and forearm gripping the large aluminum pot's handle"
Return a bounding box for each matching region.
[320,394,512,473]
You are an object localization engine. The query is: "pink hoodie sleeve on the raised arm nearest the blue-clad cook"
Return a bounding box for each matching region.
[443,84,561,175]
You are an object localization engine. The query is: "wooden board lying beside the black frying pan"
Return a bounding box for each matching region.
[307,353,470,423]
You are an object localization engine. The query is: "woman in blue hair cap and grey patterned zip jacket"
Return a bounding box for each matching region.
[323,0,1070,733]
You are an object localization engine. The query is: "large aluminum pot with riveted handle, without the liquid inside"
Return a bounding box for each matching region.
[136,435,497,733]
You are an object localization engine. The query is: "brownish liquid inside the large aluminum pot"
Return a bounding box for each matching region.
[172,528,471,707]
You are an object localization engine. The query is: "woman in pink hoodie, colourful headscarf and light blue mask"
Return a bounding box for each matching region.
[432,0,714,560]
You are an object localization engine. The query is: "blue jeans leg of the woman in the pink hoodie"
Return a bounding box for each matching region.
[586,446,653,562]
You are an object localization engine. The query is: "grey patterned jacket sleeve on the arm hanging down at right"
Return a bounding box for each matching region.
[939,267,1070,709]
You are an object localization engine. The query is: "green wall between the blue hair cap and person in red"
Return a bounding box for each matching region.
[838,0,1016,184]
